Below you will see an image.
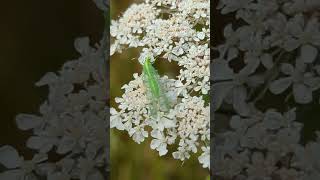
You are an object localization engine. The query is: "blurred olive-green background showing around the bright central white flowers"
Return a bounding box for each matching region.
[110,0,209,180]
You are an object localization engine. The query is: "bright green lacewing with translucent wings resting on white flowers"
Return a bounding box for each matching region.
[143,57,169,116]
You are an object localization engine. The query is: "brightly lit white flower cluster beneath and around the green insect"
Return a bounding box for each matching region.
[110,0,210,168]
